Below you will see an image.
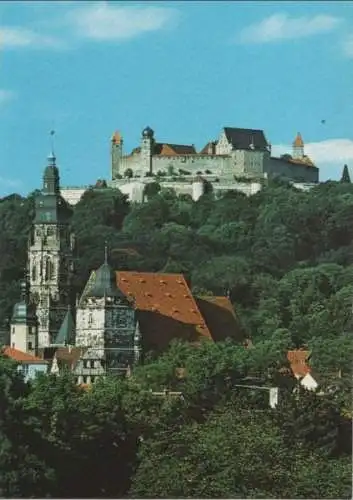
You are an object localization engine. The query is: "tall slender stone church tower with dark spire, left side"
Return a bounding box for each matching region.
[28,153,74,347]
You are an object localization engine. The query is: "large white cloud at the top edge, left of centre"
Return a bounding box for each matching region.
[69,2,176,40]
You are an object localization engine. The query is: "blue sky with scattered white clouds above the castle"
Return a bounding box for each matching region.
[0,1,353,196]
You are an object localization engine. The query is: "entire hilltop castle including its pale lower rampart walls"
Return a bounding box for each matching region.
[61,127,319,205]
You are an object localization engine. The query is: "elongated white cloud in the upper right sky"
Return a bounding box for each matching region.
[240,14,340,43]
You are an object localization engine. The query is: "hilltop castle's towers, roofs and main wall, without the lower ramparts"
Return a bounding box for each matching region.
[111,127,319,183]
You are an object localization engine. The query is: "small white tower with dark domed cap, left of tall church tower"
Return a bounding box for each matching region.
[10,279,38,356]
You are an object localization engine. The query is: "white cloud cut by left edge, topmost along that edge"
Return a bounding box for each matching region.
[0,26,64,50]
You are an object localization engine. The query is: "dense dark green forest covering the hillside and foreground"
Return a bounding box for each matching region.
[0,181,353,498]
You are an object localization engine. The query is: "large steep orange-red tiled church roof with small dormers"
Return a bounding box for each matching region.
[116,271,212,348]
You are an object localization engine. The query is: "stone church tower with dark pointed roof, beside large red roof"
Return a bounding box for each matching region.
[75,249,140,374]
